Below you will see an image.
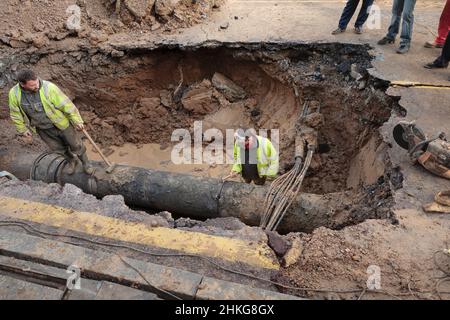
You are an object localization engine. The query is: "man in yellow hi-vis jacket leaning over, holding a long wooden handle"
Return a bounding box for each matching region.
[9,69,93,174]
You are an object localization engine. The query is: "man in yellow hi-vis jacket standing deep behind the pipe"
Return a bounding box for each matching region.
[223,129,279,185]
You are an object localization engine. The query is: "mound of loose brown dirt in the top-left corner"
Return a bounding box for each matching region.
[0,0,222,49]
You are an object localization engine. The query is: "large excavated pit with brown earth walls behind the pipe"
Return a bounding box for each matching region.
[0,44,402,229]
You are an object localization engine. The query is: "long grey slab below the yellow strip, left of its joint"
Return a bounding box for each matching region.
[0,230,202,298]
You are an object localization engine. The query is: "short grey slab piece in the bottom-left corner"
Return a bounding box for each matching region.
[0,275,64,300]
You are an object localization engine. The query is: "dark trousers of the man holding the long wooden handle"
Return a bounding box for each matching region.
[36,126,86,161]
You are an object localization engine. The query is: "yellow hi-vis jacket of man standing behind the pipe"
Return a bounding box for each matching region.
[232,136,279,177]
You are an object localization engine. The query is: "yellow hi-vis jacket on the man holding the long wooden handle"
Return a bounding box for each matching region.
[9,80,83,133]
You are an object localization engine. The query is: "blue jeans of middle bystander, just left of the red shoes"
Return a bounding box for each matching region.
[386,0,416,45]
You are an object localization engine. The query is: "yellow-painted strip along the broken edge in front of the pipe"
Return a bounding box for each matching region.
[0,196,279,270]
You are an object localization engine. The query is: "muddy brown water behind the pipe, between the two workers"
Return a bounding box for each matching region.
[86,143,231,178]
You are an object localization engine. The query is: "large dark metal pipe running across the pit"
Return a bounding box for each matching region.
[0,149,344,232]
